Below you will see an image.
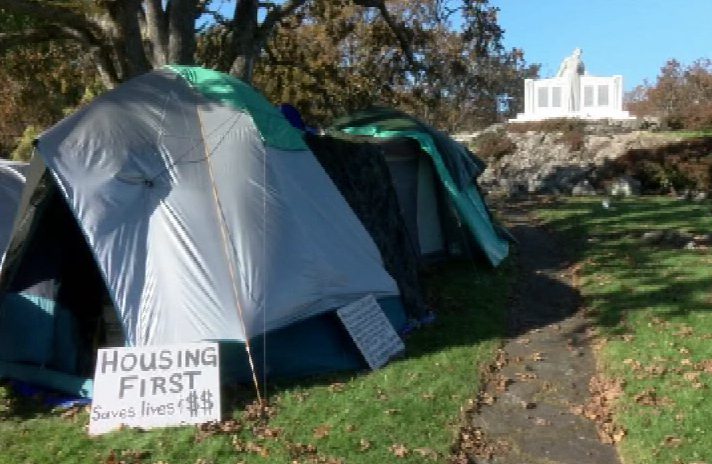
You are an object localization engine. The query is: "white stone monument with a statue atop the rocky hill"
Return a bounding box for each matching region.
[509,48,635,122]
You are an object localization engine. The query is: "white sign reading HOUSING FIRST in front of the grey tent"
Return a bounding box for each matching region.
[89,342,220,435]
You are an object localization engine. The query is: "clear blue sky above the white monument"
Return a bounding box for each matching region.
[490,0,712,90]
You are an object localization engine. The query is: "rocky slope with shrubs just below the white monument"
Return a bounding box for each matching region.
[459,120,712,196]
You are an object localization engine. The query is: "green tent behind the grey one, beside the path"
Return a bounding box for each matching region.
[328,107,511,266]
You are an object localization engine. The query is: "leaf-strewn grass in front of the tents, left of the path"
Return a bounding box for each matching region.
[0,263,514,464]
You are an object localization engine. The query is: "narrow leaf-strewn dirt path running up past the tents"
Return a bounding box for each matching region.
[456,203,619,464]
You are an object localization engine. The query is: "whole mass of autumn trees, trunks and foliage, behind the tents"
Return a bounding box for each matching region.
[0,0,536,158]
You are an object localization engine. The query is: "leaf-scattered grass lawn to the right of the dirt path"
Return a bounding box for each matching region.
[538,197,712,464]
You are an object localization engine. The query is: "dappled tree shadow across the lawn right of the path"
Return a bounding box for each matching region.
[536,197,712,333]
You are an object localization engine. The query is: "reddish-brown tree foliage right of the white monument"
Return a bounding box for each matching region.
[626,58,712,130]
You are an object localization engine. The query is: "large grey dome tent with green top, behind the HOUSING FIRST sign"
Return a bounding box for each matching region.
[0,66,406,395]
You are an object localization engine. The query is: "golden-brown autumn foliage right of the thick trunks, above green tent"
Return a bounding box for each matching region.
[255,0,538,130]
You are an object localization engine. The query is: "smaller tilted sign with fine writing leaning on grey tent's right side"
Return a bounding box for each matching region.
[336,295,405,369]
